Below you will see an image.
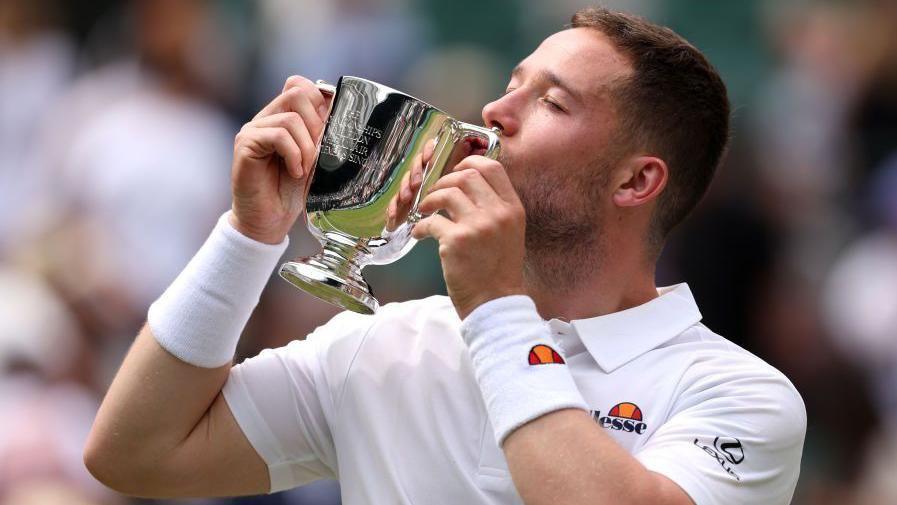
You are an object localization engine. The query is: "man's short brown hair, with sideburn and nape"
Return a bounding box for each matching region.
[569,7,729,250]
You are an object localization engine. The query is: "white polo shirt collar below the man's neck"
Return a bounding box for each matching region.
[570,283,701,373]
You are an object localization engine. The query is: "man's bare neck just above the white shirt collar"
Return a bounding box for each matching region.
[525,233,657,321]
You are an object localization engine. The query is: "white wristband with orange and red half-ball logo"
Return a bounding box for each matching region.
[461,295,588,446]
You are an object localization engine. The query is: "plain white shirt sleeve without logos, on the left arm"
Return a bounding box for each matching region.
[222,312,370,493]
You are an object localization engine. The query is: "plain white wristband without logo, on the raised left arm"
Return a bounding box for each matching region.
[147,212,289,368]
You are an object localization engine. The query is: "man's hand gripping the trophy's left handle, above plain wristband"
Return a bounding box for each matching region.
[231,76,329,244]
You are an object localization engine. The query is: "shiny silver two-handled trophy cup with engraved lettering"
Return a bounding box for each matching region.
[280,76,499,314]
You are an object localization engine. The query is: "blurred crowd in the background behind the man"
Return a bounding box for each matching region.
[0,0,897,505]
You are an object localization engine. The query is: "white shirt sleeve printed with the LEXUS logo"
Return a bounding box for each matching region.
[635,358,807,505]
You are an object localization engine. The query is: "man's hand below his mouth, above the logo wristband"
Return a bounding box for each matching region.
[412,156,526,319]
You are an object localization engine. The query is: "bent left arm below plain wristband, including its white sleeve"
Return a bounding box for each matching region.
[84,308,371,497]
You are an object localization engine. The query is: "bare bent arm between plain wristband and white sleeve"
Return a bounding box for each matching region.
[84,327,276,497]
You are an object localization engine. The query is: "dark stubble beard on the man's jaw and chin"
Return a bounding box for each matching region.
[499,149,609,292]
